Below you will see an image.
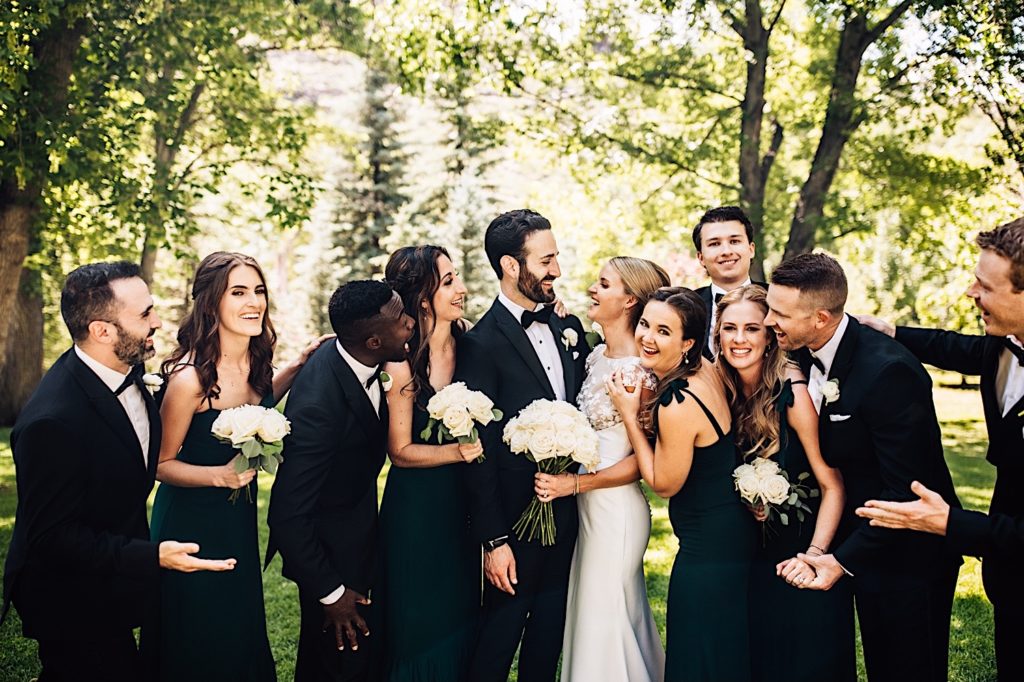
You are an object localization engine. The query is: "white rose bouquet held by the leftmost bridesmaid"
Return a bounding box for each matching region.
[210,404,292,503]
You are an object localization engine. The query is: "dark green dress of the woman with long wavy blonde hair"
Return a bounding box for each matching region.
[751,381,857,682]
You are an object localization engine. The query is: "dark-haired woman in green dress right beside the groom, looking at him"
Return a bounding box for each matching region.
[373,246,482,682]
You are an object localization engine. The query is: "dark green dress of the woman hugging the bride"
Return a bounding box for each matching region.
[665,381,758,682]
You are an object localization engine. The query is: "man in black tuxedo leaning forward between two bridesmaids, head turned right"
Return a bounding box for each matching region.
[266,281,417,682]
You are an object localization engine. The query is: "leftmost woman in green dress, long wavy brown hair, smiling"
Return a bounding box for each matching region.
[142,252,326,682]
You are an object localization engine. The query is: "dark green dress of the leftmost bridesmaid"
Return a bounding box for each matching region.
[143,396,276,682]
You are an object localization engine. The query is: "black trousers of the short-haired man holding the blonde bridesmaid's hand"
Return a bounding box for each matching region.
[856,561,959,682]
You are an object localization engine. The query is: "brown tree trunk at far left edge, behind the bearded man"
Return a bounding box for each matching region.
[0,17,85,413]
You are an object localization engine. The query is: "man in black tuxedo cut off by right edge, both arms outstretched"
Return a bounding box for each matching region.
[857,218,1024,680]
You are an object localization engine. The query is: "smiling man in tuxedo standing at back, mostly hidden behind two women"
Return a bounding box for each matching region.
[693,206,768,360]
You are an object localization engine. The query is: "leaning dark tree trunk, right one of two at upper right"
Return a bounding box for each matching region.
[782,0,912,260]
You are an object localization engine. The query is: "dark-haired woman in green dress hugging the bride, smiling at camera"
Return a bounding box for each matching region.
[608,288,757,682]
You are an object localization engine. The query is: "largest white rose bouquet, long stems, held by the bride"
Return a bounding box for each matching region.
[503,399,601,547]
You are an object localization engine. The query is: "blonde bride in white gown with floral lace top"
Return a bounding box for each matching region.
[536,257,669,682]
